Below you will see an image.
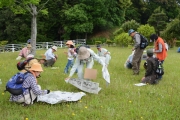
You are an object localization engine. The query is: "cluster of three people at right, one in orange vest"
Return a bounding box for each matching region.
[128,29,167,84]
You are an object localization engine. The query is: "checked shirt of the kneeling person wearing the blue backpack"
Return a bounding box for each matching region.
[10,73,47,101]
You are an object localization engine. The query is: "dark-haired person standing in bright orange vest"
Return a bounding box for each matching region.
[150,34,167,79]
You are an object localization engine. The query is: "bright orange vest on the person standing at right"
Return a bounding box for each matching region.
[155,37,167,61]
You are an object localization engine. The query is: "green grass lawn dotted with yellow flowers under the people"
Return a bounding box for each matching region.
[0,47,180,120]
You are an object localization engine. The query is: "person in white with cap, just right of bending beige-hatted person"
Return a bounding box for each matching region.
[96,45,111,66]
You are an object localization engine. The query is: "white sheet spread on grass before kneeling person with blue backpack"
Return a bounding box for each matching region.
[37,91,86,104]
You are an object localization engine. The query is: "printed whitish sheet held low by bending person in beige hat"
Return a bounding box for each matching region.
[66,78,101,94]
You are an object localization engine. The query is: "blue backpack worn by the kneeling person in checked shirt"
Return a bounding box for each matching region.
[5,72,30,95]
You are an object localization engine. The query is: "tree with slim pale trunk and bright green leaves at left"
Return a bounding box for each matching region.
[0,0,49,55]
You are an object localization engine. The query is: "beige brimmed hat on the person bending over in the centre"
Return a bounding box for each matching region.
[78,47,90,59]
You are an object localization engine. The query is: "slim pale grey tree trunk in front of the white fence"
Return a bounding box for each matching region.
[31,5,37,55]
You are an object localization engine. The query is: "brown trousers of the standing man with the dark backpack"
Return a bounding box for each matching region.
[132,47,144,74]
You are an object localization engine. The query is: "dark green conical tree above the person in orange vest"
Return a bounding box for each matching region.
[148,7,167,35]
